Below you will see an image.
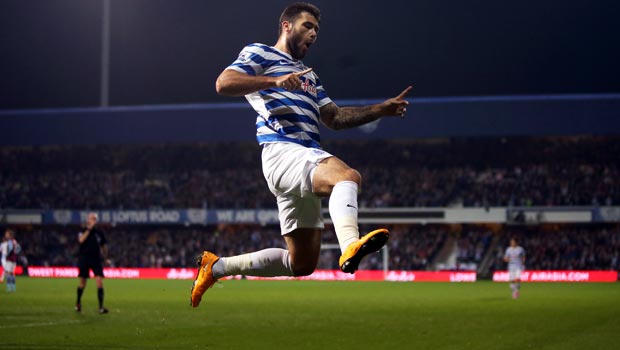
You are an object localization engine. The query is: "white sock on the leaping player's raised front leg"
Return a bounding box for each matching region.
[329,181,360,253]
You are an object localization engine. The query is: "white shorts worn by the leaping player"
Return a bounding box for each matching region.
[262,142,333,235]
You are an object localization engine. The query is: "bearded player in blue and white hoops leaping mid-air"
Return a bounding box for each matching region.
[191,3,411,307]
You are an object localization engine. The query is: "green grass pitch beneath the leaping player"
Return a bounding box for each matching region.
[0,278,620,350]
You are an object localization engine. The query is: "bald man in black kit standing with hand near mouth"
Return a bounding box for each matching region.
[75,213,108,314]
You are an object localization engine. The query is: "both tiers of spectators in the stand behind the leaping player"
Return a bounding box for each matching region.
[0,136,620,271]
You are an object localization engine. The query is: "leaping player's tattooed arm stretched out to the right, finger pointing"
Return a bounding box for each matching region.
[321,86,412,130]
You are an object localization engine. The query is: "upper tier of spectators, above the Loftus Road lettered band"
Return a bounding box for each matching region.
[0,137,620,209]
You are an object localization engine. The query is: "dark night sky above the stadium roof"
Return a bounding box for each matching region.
[0,0,620,109]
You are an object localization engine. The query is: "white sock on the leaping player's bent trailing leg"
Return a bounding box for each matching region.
[213,248,293,278]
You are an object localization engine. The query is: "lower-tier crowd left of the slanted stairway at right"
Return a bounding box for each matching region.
[15,225,446,270]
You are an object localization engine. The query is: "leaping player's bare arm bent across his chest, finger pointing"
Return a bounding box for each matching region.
[215,68,312,96]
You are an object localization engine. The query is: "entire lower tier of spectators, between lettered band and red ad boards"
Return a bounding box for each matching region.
[12,225,620,270]
